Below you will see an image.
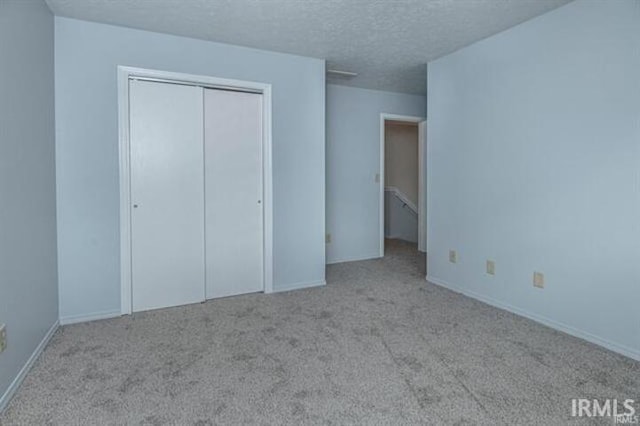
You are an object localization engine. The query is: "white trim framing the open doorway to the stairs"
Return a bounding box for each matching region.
[378,112,426,257]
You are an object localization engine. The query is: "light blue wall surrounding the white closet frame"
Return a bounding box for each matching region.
[56,17,325,318]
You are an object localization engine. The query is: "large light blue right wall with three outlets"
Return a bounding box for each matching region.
[427,0,640,357]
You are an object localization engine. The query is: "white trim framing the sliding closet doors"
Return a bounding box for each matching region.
[118,66,273,315]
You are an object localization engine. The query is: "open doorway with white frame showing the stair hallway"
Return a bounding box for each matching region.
[380,114,426,269]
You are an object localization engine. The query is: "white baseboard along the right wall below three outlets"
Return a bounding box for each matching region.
[426,275,640,361]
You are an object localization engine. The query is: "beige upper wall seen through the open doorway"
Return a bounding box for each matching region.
[384,122,418,206]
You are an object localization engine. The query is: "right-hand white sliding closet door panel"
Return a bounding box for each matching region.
[204,89,264,299]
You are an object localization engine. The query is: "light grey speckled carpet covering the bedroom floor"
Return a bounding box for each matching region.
[0,242,640,425]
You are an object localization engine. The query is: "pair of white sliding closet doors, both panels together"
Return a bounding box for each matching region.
[129,79,264,312]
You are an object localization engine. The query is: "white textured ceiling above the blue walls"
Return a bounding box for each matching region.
[47,0,570,93]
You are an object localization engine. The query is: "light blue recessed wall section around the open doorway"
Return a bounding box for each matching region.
[327,84,425,263]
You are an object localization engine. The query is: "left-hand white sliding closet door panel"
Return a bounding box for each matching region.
[129,80,205,311]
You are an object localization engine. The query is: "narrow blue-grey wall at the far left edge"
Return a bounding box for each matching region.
[0,0,58,409]
